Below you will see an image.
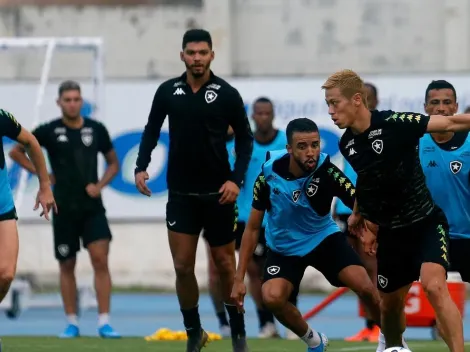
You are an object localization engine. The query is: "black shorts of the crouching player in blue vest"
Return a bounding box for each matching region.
[263,232,363,297]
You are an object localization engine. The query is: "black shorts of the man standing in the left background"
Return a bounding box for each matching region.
[52,208,112,261]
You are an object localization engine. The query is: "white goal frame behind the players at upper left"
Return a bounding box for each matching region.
[0,37,105,216]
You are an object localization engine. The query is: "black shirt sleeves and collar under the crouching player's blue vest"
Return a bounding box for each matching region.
[252,155,355,216]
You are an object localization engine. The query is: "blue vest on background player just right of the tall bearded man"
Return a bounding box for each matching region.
[227,131,287,223]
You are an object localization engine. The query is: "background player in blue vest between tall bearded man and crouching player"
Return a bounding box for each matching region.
[208,97,287,338]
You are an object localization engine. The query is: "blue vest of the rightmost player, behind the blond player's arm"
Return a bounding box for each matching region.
[419,132,470,238]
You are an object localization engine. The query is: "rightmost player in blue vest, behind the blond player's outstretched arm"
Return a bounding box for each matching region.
[419,80,470,282]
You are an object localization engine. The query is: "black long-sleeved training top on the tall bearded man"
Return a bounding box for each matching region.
[136,72,253,194]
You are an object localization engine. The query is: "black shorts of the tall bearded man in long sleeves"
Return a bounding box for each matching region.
[166,193,238,247]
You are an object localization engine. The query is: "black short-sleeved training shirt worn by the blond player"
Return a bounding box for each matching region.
[339,111,434,228]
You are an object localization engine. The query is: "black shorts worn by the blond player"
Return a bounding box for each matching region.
[377,209,450,293]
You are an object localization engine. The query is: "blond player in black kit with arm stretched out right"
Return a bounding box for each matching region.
[322,70,470,352]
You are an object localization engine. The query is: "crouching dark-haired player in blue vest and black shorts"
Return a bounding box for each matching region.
[232,118,380,352]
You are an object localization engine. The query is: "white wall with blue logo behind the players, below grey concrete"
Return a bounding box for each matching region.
[6,73,470,290]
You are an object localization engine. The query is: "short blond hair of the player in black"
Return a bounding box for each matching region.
[321,70,367,106]
